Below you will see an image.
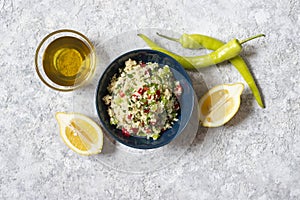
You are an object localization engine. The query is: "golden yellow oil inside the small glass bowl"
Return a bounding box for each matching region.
[43,36,92,86]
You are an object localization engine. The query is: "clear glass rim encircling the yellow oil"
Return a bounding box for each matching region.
[34,29,96,92]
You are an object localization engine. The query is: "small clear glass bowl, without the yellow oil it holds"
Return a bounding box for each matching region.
[35,29,96,91]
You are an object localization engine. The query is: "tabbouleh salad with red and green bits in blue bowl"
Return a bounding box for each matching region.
[103,59,182,140]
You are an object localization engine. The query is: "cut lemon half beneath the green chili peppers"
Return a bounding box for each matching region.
[199,83,244,127]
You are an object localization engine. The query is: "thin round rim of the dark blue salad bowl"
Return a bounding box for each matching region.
[95,48,195,150]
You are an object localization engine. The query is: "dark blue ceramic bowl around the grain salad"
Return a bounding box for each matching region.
[96,49,195,149]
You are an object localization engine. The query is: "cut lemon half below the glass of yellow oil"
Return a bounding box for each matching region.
[55,112,103,155]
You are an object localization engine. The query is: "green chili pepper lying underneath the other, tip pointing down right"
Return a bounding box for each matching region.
[157,33,265,108]
